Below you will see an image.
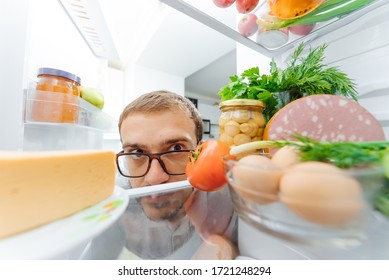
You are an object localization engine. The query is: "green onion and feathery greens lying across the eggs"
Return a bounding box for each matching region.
[230,135,389,168]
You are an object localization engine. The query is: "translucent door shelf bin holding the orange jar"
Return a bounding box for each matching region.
[23,89,118,151]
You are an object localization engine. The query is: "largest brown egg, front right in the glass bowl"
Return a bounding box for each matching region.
[280,162,363,226]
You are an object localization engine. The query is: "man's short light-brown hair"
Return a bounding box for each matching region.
[119,90,203,143]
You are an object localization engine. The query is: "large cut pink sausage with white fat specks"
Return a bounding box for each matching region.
[263,94,385,142]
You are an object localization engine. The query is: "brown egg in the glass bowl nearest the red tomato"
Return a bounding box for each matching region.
[231,155,281,204]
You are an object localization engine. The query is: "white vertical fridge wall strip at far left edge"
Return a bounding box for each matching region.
[0,0,28,150]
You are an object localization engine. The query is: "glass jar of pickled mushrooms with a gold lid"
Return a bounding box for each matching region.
[219,99,265,147]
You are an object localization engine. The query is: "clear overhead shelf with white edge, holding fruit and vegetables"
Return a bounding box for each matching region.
[160,0,388,57]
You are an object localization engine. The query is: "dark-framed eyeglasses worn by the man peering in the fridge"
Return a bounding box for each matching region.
[116,150,192,178]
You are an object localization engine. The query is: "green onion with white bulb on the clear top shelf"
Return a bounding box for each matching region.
[257,0,374,30]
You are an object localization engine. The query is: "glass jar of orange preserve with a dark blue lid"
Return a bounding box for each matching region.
[31,68,81,123]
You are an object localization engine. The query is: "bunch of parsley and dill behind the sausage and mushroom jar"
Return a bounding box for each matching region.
[218,44,357,122]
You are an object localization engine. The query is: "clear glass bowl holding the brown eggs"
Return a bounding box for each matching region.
[224,159,386,242]
